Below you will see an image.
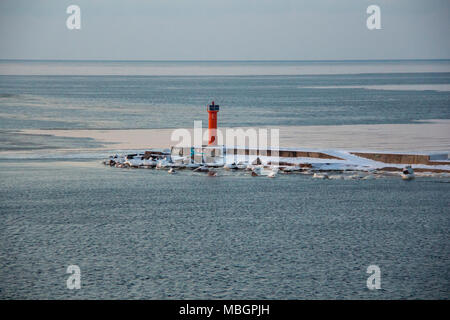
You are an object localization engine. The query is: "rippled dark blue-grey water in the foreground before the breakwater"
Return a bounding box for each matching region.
[0,161,450,299]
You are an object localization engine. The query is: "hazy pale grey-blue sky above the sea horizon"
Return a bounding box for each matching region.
[0,0,450,60]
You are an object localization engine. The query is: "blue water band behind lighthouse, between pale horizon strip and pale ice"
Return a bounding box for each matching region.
[0,73,450,130]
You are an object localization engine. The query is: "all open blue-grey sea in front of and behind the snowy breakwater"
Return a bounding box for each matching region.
[0,61,450,299]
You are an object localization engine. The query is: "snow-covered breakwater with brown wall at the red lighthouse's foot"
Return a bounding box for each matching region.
[104,146,450,179]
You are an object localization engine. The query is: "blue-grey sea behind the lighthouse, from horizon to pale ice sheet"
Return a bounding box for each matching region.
[0,60,450,151]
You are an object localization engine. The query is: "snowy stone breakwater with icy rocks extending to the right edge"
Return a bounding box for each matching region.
[103,150,450,180]
